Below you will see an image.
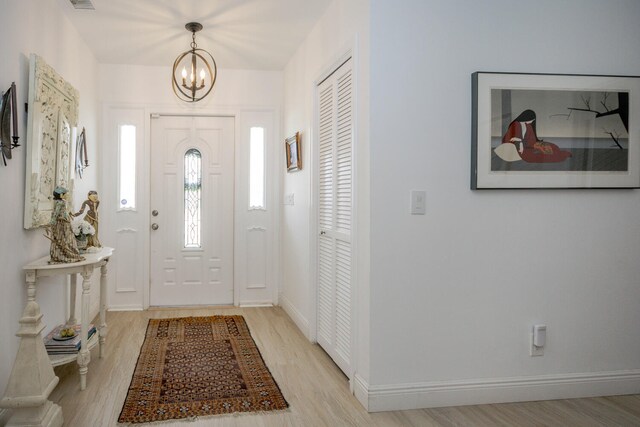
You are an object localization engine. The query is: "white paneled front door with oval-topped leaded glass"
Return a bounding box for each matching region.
[149,116,235,306]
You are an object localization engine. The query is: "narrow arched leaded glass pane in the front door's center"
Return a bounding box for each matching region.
[184,148,202,248]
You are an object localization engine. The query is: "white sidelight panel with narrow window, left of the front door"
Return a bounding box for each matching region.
[103,106,149,310]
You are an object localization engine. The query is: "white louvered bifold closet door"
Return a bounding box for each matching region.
[317,59,353,375]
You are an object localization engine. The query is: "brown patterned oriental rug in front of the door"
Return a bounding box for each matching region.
[118,316,289,423]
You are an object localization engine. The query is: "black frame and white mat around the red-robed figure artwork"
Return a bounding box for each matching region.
[471,71,640,190]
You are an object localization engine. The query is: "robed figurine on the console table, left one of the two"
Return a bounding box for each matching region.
[45,187,84,264]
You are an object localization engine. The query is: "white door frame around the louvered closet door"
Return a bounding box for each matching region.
[309,45,359,386]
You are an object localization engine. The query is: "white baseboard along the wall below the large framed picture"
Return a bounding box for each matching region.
[354,369,640,412]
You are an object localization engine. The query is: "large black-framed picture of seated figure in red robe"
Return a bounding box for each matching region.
[471,72,640,190]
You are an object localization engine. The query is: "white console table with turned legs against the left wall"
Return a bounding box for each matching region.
[0,247,113,427]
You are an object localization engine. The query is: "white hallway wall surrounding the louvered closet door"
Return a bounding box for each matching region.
[281,0,369,384]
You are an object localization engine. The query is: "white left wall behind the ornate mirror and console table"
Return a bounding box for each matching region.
[0,0,98,394]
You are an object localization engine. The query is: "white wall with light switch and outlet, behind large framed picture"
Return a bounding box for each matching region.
[368,0,640,409]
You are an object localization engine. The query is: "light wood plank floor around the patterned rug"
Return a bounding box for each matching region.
[50,308,640,427]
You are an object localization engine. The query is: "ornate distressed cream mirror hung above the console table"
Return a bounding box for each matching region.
[24,54,79,229]
